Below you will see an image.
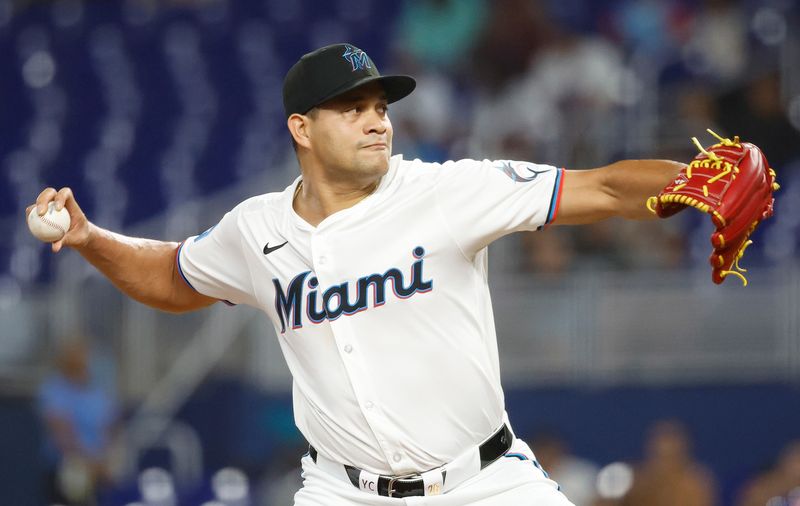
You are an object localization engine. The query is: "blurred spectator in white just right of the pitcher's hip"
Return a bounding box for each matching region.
[531,431,598,506]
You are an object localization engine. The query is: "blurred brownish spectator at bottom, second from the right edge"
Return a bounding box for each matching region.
[622,420,716,506]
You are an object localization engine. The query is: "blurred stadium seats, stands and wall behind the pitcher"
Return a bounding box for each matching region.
[0,0,800,506]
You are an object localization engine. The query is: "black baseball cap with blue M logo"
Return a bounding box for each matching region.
[283,43,417,118]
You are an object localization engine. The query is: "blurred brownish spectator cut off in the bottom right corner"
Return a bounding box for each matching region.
[736,440,800,506]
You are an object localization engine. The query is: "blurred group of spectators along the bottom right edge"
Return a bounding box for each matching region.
[531,419,800,506]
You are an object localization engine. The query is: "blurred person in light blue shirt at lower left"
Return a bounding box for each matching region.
[39,339,116,506]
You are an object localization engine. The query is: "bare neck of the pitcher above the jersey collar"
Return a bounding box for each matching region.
[293,173,380,227]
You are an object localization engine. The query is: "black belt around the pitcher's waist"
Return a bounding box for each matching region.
[308,424,514,497]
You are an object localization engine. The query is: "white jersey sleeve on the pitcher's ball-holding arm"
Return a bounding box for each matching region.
[176,205,256,305]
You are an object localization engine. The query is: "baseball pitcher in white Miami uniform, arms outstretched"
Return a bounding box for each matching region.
[29,44,775,506]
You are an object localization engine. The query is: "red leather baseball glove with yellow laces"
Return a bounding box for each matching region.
[647,130,780,286]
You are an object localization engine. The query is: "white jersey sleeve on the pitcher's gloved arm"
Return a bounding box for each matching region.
[436,160,564,255]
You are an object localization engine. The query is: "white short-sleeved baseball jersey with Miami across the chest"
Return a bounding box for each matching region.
[178,155,563,475]
